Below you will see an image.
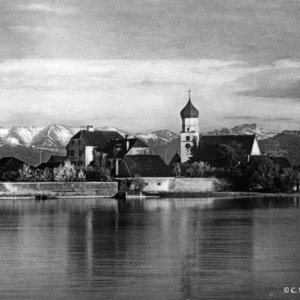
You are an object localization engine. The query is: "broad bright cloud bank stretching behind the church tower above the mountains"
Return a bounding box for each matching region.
[0,59,298,132]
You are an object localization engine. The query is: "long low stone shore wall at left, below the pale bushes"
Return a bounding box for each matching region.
[0,182,118,197]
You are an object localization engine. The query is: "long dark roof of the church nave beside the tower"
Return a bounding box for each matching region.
[200,135,256,154]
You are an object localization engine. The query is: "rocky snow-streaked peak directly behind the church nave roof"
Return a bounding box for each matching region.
[206,123,277,140]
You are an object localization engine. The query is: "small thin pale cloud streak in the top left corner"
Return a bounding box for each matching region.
[16,3,78,16]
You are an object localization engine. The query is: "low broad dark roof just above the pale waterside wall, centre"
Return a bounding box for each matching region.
[119,154,172,177]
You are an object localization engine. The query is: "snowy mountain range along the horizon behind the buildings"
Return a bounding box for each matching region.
[0,124,300,165]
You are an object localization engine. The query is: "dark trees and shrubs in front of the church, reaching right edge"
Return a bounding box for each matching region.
[171,140,300,192]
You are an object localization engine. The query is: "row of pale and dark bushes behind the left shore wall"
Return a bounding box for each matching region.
[0,160,111,182]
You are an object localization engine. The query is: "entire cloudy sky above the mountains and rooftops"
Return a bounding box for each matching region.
[0,0,300,132]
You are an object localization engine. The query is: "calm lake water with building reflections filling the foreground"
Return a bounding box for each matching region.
[0,197,300,300]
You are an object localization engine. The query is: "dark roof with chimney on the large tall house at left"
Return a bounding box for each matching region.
[71,130,124,149]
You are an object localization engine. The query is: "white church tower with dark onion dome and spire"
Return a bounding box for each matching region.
[180,91,199,163]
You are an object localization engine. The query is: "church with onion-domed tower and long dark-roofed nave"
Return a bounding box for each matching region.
[179,92,261,165]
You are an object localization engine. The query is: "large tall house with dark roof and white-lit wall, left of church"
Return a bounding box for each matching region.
[66,126,124,166]
